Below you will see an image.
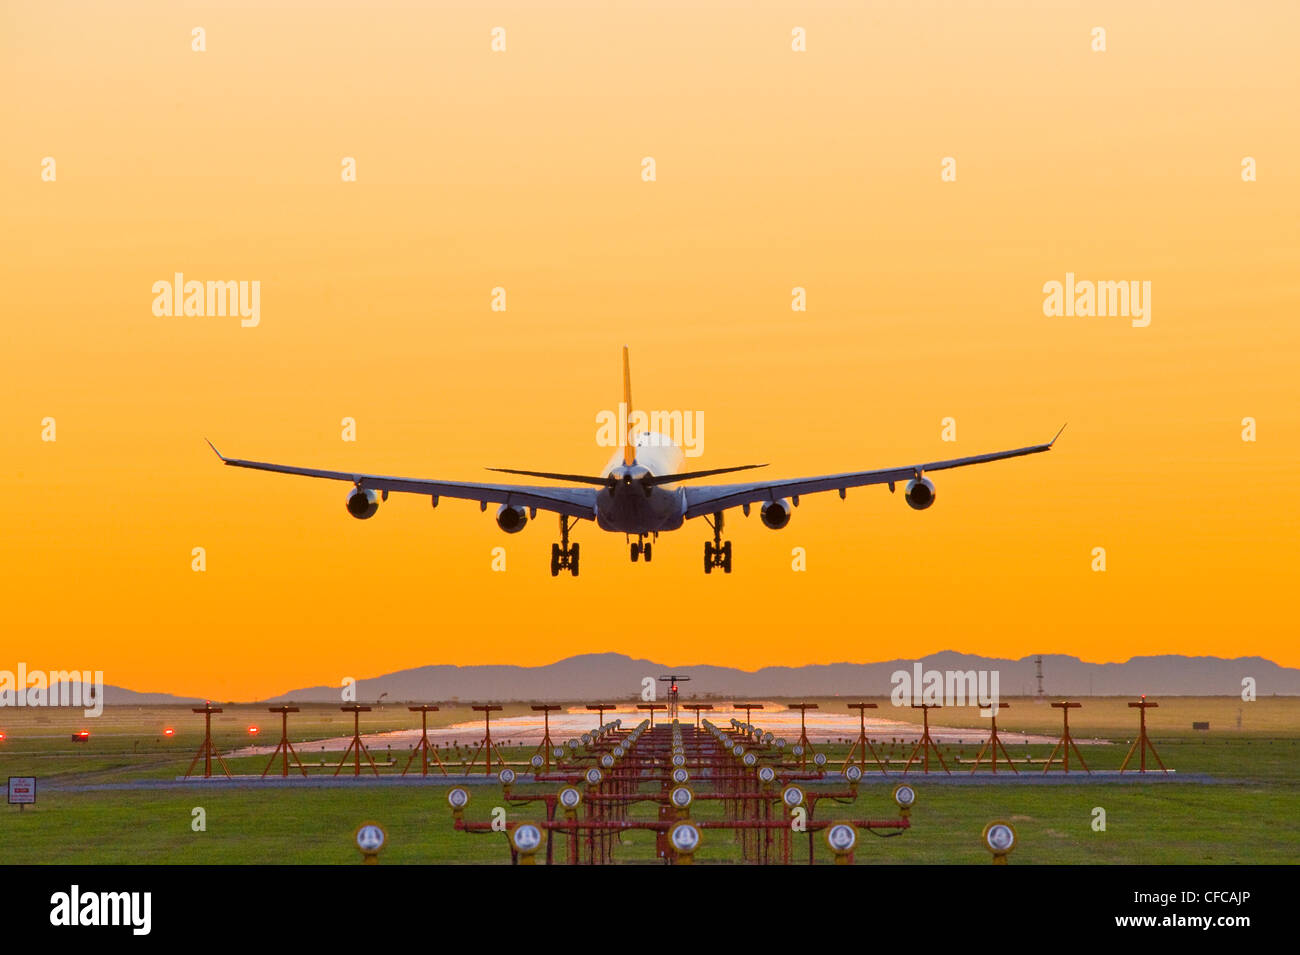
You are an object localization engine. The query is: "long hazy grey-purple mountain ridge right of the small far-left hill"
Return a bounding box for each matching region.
[258,651,1300,703]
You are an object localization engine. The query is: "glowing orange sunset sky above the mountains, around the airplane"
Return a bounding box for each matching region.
[0,1,1300,698]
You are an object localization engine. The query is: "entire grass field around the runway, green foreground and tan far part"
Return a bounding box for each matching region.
[0,698,1300,864]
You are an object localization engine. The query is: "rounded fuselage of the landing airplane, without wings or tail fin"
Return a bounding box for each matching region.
[595,434,686,534]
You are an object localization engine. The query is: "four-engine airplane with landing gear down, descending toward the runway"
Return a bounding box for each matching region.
[204,346,1065,577]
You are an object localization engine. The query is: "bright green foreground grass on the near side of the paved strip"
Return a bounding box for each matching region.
[0,777,1300,864]
